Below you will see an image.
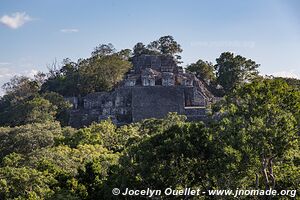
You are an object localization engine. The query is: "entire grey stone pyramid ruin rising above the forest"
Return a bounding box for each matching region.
[69,55,214,127]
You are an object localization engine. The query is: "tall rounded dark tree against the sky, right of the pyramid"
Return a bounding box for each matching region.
[215,52,259,92]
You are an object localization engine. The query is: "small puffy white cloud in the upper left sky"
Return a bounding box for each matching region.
[0,12,32,29]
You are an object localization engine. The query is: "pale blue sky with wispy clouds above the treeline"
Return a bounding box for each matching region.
[0,0,300,95]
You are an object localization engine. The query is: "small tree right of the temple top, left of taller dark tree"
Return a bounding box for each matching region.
[186,60,216,82]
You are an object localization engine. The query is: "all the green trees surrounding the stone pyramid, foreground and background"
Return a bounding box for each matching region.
[0,36,300,200]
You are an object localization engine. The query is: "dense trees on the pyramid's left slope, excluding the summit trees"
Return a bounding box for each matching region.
[41,47,131,96]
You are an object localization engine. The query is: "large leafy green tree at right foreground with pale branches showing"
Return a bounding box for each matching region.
[215,79,300,189]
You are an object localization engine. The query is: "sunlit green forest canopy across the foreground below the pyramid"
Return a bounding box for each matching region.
[0,79,300,199]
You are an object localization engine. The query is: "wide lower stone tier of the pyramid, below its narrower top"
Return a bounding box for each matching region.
[69,86,206,127]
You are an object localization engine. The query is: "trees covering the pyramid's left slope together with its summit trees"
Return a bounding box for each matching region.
[41,36,182,96]
